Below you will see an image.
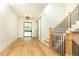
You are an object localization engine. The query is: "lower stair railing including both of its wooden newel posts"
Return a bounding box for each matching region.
[48,28,72,56]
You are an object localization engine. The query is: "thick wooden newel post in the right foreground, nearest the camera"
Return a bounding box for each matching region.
[65,31,72,56]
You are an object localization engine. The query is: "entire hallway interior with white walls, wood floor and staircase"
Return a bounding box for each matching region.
[0,3,79,56]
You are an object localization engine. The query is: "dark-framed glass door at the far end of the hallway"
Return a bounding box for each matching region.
[23,22,32,37]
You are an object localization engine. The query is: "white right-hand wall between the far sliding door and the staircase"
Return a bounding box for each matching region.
[41,4,65,40]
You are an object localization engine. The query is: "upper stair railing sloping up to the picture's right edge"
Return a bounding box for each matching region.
[53,5,79,32]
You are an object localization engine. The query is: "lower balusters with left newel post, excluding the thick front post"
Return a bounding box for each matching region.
[49,28,65,56]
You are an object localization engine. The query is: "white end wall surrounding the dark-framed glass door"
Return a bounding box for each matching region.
[18,17,37,38]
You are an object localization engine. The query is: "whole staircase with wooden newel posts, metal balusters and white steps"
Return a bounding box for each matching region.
[49,5,79,56]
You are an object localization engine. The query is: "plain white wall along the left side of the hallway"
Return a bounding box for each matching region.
[0,4,18,51]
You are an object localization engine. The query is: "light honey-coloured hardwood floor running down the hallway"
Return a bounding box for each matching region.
[0,39,58,56]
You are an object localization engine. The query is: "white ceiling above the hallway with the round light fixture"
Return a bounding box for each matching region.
[9,3,48,18]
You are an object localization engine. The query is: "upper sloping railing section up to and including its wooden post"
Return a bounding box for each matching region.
[53,14,71,33]
